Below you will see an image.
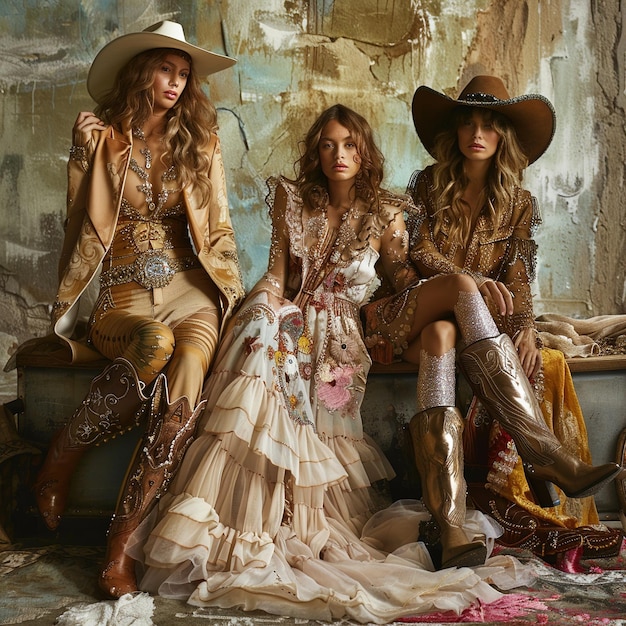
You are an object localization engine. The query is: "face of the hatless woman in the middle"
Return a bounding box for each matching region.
[317,120,361,181]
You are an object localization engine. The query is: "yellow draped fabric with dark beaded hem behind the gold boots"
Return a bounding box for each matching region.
[463,348,623,563]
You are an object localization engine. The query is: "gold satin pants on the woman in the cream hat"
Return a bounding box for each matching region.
[89,268,220,407]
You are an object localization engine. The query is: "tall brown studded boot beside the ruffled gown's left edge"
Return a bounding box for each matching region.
[98,375,206,598]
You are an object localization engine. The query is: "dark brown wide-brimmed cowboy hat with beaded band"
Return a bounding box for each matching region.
[413,76,556,164]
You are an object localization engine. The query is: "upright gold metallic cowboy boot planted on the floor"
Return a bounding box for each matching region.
[409,407,487,569]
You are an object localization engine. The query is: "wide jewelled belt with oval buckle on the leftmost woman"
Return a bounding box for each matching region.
[100,250,200,289]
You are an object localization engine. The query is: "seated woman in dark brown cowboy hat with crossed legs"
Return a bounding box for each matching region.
[364,76,621,567]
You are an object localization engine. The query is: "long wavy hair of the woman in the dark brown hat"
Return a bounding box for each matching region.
[433,106,528,245]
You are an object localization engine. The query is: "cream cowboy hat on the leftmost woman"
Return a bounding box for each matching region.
[87,20,237,102]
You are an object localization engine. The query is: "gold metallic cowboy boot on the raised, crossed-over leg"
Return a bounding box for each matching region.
[459,334,622,498]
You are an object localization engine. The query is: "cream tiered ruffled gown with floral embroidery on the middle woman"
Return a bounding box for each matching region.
[130,176,529,623]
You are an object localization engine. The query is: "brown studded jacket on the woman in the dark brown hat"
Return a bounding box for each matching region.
[407,166,541,336]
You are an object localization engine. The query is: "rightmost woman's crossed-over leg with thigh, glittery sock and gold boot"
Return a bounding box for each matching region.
[402,274,621,497]
